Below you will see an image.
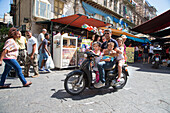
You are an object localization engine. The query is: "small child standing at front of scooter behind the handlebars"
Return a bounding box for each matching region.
[93,41,102,83]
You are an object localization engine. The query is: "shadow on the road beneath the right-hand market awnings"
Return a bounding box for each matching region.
[128,62,170,74]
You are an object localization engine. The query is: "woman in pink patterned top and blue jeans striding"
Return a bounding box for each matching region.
[0,27,32,88]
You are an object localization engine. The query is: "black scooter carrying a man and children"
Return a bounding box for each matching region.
[64,52,129,95]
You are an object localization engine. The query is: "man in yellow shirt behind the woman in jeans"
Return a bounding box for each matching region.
[15,31,27,65]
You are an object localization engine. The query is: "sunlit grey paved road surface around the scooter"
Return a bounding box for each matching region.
[0,63,170,113]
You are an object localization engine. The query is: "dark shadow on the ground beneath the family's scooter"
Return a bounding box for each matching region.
[51,88,117,101]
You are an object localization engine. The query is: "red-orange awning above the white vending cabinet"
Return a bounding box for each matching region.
[51,14,109,28]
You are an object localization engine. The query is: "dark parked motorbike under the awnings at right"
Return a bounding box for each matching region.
[152,47,162,69]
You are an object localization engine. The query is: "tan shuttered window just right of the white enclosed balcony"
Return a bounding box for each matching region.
[54,0,64,18]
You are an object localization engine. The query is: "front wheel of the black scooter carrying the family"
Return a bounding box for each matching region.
[64,74,86,95]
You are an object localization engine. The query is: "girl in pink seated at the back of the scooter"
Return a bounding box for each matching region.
[116,38,125,82]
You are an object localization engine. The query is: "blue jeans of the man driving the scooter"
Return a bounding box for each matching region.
[97,61,114,83]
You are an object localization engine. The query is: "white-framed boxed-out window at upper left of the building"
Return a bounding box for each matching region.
[35,0,51,19]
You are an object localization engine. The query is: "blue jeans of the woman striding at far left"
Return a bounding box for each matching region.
[0,59,27,86]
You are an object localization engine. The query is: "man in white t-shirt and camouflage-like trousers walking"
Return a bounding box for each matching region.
[24,31,39,77]
